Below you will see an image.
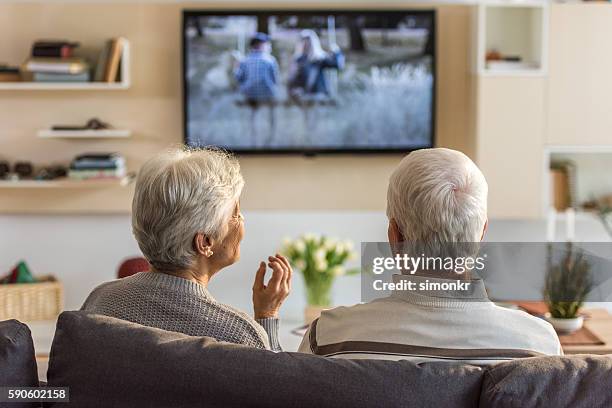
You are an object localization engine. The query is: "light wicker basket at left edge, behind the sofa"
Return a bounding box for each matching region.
[0,282,64,320]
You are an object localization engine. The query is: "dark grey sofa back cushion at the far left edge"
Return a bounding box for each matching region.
[0,320,38,387]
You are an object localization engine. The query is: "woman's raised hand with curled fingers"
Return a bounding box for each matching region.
[253,254,293,319]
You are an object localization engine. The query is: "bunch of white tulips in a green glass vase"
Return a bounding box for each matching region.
[281,234,359,323]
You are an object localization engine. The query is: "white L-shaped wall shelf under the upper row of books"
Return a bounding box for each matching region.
[0,40,131,91]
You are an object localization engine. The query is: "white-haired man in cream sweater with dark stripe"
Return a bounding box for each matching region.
[299,149,561,364]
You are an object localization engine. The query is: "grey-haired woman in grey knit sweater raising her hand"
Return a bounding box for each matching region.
[82,150,292,351]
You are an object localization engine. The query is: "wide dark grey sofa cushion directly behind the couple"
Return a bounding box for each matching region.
[47,312,482,408]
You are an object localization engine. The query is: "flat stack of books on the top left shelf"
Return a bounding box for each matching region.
[22,40,90,82]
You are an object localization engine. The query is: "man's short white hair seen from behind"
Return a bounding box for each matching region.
[387,148,488,255]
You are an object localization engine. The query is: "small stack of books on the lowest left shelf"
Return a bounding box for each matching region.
[68,153,127,180]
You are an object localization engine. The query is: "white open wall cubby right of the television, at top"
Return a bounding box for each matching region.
[475,0,548,76]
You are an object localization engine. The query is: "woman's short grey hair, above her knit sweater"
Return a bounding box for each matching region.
[132,148,244,271]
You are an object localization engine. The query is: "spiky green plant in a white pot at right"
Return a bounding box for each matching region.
[544,242,592,333]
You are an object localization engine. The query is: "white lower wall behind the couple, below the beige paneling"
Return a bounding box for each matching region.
[0,211,609,319]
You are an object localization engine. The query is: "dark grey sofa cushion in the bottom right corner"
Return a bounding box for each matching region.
[480,355,612,408]
